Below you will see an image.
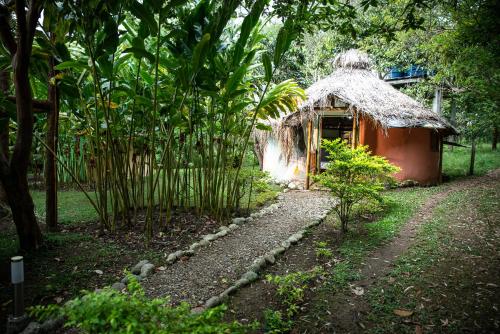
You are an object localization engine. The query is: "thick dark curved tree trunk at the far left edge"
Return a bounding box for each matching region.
[0,0,42,250]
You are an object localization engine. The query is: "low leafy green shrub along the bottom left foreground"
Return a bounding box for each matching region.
[31,276,248,334]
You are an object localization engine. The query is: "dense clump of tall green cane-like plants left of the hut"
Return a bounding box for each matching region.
[23,0,310,240]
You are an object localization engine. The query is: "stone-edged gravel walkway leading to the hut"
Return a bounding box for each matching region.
[143,191,332,306]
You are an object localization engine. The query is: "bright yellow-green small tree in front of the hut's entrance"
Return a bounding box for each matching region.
[314,138,399,232]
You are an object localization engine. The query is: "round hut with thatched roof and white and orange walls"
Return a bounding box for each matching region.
[255,50,457,188]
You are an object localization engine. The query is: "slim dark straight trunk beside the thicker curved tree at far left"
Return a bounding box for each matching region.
[45,40,59,232]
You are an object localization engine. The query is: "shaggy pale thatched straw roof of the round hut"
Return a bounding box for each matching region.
[283,50,456,133]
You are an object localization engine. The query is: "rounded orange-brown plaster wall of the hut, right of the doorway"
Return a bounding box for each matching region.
[359,119,440,185]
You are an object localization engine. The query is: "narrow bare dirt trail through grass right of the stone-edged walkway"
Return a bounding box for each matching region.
[310,170,500,333]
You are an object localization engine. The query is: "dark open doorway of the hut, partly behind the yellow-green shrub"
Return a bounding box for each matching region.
[319,115,353,171]
